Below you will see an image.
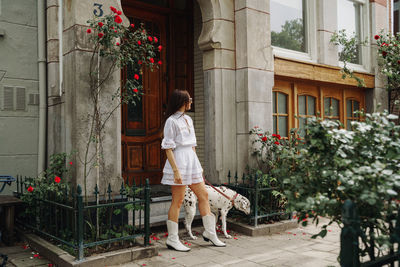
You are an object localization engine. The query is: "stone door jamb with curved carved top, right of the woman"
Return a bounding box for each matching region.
[198,0,236,183]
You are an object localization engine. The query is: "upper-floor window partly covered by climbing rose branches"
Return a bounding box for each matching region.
[337,0,363,64]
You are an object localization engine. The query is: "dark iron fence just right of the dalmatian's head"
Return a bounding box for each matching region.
[225,171,291,226]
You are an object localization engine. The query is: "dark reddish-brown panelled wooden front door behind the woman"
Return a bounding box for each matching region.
[122,9,167,185]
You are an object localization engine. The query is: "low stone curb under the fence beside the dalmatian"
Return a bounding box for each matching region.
[226,218,298,236]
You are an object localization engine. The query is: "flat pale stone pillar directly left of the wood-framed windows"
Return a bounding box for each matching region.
[235,0,274,178]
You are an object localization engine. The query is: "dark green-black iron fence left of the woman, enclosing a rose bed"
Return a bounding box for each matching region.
[16,176,150,260]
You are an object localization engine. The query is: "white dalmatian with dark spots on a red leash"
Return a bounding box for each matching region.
[183,185,250,239]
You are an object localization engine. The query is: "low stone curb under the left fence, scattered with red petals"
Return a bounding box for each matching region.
[17,229,158,267]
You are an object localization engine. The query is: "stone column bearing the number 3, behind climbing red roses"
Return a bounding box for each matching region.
[57,0,125,194]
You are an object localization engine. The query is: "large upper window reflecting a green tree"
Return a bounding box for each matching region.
[270,0,308,53]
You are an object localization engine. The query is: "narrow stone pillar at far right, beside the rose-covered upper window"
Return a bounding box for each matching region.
[365,0,389,112]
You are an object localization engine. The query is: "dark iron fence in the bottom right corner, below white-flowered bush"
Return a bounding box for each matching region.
[340,200,400,267]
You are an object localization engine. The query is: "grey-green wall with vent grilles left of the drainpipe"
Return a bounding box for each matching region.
[0,0,39,194]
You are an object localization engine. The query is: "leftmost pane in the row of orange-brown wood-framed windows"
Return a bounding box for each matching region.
[272,92,289,137]
